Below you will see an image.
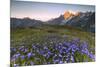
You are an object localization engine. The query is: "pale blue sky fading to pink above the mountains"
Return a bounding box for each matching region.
[11,1,95,21]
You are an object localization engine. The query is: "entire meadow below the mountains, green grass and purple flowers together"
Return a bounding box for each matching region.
[10,26,95,67]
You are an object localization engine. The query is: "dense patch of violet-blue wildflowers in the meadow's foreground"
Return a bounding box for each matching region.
[11,39,95,66]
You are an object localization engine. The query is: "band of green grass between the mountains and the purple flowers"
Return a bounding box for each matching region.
[11,25,95,48]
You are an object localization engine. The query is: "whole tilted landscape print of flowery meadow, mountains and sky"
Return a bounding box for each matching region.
[10,0,95,67]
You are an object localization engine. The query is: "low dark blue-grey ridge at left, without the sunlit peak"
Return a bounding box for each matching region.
[11,18,43,28]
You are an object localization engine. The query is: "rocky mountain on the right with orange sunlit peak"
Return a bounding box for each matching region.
[48,12,95,32]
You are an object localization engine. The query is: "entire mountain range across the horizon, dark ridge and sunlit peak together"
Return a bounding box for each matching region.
[11,11,95,32]
